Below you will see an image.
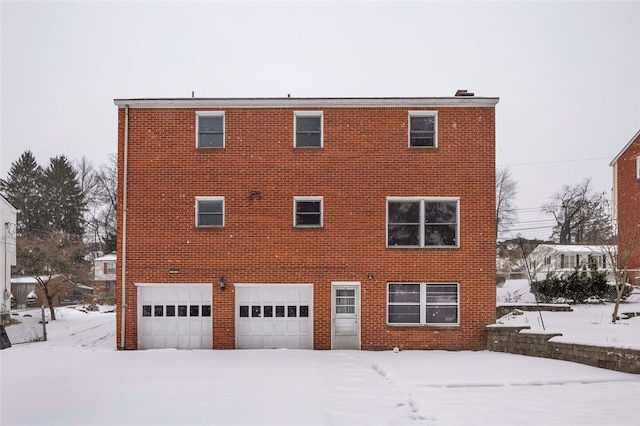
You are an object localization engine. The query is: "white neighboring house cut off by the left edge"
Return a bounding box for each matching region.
[0,194,18,314]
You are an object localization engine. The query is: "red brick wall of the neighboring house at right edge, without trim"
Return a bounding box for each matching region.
[617,136,640,284]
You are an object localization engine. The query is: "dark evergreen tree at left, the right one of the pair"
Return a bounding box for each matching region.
[42,155,86,236]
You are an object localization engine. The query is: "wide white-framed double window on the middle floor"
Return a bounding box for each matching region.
[387,197,460,247]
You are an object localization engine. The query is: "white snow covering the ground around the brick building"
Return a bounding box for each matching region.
[0,304,640,426]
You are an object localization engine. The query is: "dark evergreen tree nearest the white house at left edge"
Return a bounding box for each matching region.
[0,151,47,236]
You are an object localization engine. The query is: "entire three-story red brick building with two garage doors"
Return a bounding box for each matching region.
[115,95,498,350]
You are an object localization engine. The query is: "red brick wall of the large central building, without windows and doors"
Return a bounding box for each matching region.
[116,103,496,349]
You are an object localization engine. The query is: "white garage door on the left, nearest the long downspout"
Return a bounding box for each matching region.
[136,284,213,349]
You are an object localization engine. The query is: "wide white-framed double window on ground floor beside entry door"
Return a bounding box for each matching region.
[387,283,460,325]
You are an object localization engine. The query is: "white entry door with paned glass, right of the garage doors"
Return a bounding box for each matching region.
[331,282,360,350]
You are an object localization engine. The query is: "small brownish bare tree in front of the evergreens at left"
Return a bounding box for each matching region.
[16,231,90,320]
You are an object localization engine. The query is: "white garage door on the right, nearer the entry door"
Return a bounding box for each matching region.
[235,284,313,349]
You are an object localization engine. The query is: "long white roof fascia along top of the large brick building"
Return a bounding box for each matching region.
[113,96,499,108]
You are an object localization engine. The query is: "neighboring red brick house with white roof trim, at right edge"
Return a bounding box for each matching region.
[609,131,640,285]
